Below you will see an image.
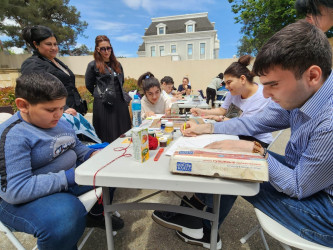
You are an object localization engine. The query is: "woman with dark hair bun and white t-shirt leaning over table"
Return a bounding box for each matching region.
[191,55,272,147]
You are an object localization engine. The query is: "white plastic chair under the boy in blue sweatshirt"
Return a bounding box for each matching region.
[0,187,102,250]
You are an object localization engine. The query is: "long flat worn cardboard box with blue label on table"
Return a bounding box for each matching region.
[170,148,268,182]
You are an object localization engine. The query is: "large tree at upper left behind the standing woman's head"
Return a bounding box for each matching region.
[0,0,88,54]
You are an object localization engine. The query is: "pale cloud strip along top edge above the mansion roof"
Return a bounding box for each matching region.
[123,0,215,14]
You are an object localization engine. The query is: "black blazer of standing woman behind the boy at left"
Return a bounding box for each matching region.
[21,51,83,113]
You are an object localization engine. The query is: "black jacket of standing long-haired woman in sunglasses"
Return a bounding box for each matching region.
[85,61,126,100]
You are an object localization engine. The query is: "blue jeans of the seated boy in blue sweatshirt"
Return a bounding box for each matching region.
[0,185,115,250]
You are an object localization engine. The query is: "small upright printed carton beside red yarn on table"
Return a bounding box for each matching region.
[132,128,149,162]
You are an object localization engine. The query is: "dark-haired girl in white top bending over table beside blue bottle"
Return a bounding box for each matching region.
[138,72,171,118]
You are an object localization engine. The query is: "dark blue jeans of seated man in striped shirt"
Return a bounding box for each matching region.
[196,152,333,247]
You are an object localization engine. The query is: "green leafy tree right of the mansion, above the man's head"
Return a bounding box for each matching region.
[228,0,299,56]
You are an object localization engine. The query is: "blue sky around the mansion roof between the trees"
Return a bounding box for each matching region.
[69,0,241,58]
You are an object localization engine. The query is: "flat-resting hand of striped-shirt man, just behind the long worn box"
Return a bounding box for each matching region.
[205,140,254,153]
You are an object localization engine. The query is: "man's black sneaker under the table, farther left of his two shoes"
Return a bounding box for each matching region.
[152,196,203,239]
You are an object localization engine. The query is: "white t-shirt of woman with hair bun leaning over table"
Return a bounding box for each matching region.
[221,83,273,143]
